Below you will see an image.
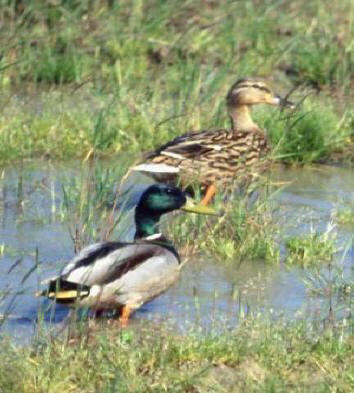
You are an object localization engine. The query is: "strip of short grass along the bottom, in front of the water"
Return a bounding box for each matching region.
[0,316,354,393]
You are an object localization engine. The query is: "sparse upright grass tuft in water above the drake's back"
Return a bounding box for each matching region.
[56,158,132,250]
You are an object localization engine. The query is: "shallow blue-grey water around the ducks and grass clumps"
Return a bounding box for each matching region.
[0,161,354,342]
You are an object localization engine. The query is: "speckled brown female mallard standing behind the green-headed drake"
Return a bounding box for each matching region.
[133,78,293,205]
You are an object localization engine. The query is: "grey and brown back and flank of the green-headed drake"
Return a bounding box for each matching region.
[58,240,180,308]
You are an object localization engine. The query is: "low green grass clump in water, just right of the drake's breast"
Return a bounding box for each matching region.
[168,185,279,264]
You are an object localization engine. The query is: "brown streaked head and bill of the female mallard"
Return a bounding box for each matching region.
[226,78,294,109]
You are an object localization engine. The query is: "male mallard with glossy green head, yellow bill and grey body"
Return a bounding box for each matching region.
[38,184,214,325]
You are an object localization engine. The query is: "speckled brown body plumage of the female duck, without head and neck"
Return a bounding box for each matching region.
[144,125,269,187]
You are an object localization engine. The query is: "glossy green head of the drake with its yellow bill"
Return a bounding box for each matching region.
[135,184,216,238]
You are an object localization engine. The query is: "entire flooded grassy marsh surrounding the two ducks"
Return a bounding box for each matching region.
[0,0,354,393]
